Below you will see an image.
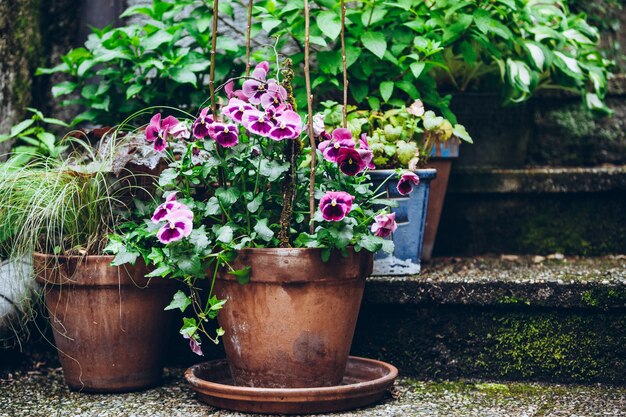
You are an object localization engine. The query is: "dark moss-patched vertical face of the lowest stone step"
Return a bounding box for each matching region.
[353,305,626,383]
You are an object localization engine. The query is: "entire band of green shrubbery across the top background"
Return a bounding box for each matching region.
[38,0,610,129]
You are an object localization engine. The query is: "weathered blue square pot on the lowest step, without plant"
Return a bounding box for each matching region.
[369,169,437,275]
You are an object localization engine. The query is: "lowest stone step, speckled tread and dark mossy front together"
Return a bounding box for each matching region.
[352,255,626,384]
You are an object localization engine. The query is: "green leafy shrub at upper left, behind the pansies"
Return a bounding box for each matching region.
[37,0,243,125]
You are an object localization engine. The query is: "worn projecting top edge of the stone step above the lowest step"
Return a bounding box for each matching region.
[448,165,626,194]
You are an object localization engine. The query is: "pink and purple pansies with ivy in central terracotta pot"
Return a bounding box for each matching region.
[114,53,412,387]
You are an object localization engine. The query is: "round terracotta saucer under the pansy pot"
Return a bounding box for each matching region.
[185,356,398,414]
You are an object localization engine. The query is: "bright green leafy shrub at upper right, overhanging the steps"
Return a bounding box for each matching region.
[250,0,609,117]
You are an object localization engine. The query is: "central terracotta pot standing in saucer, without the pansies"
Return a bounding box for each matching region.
[215,249,372,388]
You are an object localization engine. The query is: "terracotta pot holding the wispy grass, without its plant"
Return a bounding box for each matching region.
[34,253,174,392]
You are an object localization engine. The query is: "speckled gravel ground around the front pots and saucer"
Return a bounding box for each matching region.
[0,367,626,417]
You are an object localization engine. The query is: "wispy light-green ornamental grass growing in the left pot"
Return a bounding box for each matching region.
[0,139,136,256]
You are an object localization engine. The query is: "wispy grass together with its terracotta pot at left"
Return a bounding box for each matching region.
[0,139,173,392]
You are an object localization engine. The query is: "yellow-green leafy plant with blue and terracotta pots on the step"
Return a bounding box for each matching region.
[317,100,472,275]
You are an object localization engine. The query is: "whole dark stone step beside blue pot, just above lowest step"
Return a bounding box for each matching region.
[434,165,626,256]
